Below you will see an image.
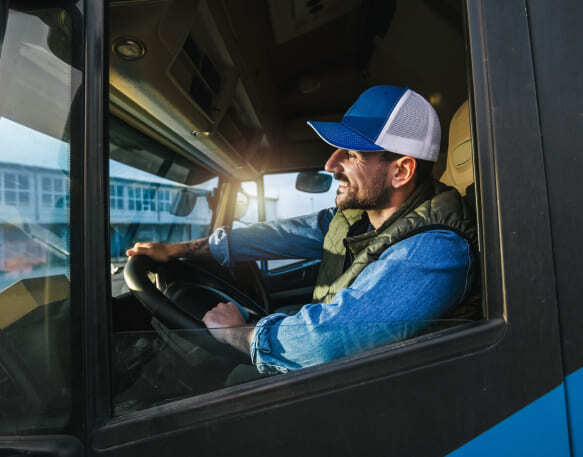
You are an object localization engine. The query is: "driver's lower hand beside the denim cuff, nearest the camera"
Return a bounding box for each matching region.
[202,302,253,354]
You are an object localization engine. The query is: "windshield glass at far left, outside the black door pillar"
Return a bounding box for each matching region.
[0,3,82,435]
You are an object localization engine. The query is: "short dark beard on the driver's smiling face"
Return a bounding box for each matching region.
[334,173,393,210]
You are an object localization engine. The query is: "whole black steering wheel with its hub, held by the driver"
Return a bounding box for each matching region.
[124,255,265,364]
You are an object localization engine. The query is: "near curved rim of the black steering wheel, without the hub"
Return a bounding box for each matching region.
[124,255,250,364]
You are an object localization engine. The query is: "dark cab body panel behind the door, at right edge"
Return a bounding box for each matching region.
[528,1,583,456]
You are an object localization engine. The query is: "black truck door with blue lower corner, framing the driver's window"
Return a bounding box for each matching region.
[87,0,576,456]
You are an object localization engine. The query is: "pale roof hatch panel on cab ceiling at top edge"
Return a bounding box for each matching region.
[268,0,361,44]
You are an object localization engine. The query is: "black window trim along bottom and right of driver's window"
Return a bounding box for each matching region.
[90,2,507,445]
